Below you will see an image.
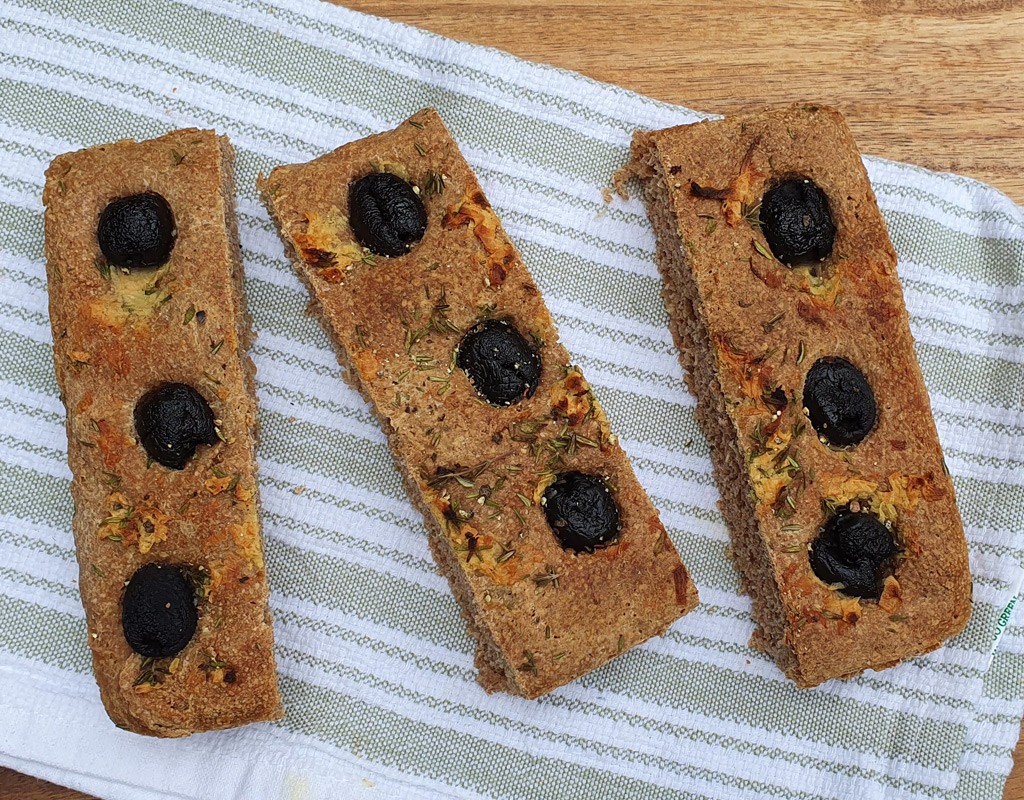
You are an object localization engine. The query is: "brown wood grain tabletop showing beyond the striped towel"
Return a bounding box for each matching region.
[0,0,1024,800]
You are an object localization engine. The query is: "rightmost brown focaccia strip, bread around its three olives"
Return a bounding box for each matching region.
[631,107,971,686]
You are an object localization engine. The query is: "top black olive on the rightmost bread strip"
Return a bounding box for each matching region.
[759,178,836,266]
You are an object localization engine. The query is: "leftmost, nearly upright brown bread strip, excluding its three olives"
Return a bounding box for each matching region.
[43,129,282,736]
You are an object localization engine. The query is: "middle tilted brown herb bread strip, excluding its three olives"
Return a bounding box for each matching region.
[260,109,697,698]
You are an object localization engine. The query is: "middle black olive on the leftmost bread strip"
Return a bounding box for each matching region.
[135,383,218,469]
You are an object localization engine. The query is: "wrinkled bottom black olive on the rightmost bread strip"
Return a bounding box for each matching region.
[810,507,899,600]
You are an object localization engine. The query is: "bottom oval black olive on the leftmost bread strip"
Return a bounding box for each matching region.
[121,562,199,659]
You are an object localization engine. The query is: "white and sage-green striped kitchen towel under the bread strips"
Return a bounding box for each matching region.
[0,0,1024,800]
